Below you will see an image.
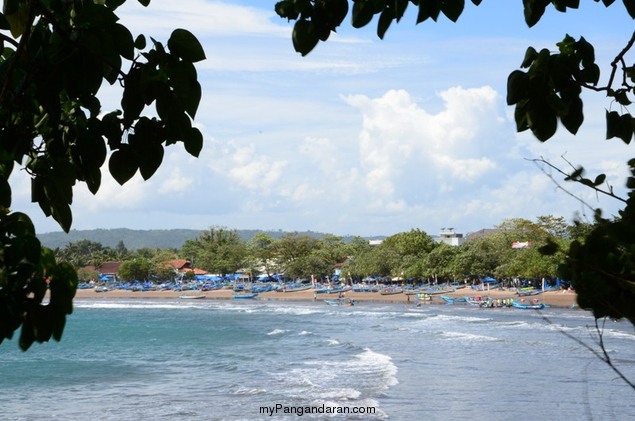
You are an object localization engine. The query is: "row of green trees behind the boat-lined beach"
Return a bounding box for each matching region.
[60,215,592,281]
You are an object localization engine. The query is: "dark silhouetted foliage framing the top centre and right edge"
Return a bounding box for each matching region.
[275,0,635,324]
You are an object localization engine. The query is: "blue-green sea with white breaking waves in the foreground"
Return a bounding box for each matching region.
[0,299,635,421]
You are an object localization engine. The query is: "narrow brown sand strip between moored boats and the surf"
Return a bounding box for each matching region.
[75,288,576,308]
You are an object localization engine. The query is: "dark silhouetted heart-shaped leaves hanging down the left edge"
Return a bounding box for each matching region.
[0,0,205,349]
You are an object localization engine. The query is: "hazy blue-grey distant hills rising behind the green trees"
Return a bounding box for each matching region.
[37,228,383,250]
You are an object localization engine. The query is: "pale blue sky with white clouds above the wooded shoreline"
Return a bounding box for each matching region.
[11,0,633,236]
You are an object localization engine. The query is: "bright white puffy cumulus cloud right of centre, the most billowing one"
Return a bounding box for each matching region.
[346,87,511,210]
